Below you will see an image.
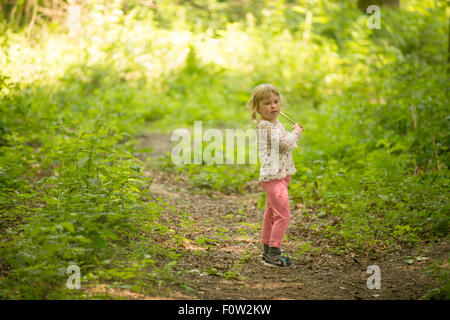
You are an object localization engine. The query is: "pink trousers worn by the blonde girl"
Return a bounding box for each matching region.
[261,176,291,248]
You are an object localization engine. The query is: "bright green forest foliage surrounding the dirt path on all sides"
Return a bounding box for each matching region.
[0,0,450,299]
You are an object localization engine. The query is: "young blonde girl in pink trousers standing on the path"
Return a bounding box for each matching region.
[247,84,303,267]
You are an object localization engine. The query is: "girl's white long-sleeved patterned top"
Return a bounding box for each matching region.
[257,119,301,181]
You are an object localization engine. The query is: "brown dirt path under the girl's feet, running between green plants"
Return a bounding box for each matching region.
[135,134,450,300]
